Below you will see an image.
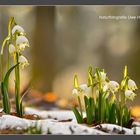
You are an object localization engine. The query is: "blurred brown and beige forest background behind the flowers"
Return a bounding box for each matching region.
[0,6,140,109]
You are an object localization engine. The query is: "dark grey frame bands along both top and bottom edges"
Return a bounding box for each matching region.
[0,0,140,140]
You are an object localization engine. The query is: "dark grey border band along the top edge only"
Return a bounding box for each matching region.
[0,0,140,5]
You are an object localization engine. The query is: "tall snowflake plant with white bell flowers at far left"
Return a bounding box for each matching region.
[0,17,29,116]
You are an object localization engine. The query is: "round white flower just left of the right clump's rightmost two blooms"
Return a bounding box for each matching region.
[108,81,119,93]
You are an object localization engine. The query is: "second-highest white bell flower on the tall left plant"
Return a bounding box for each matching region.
[16,36,29,52]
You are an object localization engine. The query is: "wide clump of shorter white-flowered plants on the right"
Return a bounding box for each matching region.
[72,66,137,127]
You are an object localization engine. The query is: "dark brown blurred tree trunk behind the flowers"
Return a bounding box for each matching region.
[32,6,56,91]
